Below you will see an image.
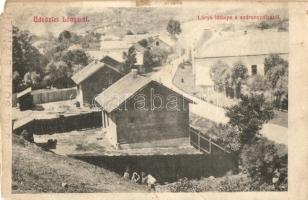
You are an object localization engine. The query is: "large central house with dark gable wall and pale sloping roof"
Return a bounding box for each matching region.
[95,70,192,147]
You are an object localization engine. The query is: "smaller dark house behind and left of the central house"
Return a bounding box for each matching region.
[72,58,124,105]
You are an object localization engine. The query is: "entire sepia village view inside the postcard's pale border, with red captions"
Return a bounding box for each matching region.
[10,3,289,194]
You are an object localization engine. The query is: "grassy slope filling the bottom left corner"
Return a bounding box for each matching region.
[12,136,146,193]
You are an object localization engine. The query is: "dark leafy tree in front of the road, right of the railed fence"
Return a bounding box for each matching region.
[226,94,274,144]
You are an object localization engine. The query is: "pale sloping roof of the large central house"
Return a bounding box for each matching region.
[95,72,192,113]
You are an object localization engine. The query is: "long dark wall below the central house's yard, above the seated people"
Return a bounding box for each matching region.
[72,154,238,183]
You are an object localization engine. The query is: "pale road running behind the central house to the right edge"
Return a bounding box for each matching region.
[152,56,288,145]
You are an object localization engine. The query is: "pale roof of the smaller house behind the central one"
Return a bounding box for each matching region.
[72,60,123,84]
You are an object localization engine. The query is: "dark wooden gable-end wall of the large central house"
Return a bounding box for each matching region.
[113,82,189,143]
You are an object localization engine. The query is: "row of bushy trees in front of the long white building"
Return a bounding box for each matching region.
[210,54,289,110]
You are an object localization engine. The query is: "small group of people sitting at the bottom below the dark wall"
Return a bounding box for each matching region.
[123,168,157,191]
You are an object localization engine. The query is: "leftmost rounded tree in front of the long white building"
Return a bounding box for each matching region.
[210,60,230,92]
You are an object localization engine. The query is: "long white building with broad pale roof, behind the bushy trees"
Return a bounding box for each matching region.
[192,30,288,87]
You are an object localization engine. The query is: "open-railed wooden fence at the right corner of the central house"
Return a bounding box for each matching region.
[189,127,229,154]
